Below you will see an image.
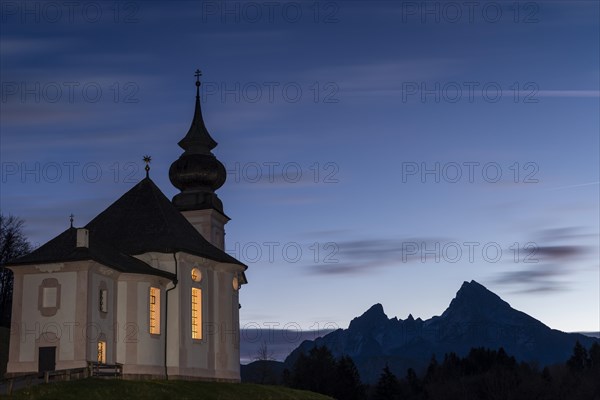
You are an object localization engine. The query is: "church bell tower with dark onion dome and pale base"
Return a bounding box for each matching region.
[169,70,229,250]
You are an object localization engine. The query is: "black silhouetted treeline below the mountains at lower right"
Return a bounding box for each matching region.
[283,342,600,400]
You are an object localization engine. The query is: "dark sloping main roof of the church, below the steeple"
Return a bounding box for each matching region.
[8,177,245,276]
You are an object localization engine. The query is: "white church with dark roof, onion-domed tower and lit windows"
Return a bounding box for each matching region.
[6,70,247,382]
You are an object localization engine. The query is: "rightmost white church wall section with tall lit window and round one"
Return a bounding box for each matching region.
[161,254,239,381]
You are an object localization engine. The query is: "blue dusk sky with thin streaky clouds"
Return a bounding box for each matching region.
[0,0,600,350]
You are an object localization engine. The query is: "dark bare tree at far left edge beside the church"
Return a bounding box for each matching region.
[0,214,31,327]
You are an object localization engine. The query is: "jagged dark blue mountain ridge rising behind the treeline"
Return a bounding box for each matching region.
[285,281,596,383]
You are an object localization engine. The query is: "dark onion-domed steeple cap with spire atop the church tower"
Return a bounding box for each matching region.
[169,70,227,216]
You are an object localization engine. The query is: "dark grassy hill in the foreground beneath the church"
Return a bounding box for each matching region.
[0,379,331,400]
